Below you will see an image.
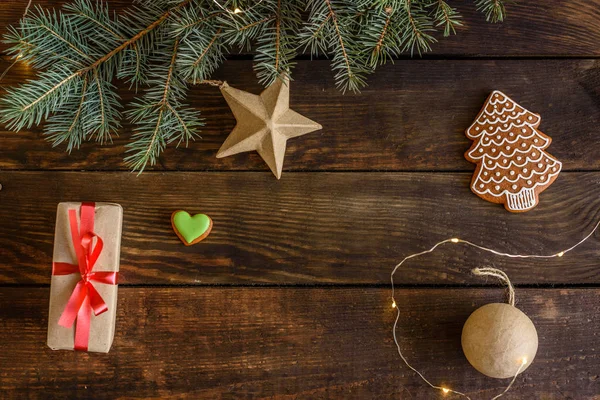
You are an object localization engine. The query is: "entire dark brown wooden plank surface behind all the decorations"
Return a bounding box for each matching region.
[0,0,600,400]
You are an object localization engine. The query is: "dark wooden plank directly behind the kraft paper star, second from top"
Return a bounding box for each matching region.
[0,60,600,171]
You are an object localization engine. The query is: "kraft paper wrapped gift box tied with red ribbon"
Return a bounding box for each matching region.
[48,202,123,353]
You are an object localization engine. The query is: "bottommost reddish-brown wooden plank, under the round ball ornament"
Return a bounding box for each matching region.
[0,287,600,400]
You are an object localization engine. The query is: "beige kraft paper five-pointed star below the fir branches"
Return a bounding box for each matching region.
[217,77,322,179]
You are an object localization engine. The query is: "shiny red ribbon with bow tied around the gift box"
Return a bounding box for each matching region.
[52,203,118,351]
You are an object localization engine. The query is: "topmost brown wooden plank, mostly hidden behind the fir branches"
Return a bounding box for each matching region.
[0,0,600,56]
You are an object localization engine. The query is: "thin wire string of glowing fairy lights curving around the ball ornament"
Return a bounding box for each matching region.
[390,221,600,400]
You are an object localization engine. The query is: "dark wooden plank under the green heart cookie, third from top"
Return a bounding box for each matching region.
[0,172,600,285]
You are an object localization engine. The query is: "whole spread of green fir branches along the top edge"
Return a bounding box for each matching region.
[0,0,506,171]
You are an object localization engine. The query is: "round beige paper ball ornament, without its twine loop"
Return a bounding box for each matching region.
[462,303,538,378]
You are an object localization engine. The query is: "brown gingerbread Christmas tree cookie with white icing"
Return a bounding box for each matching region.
[465,90,562,212]
